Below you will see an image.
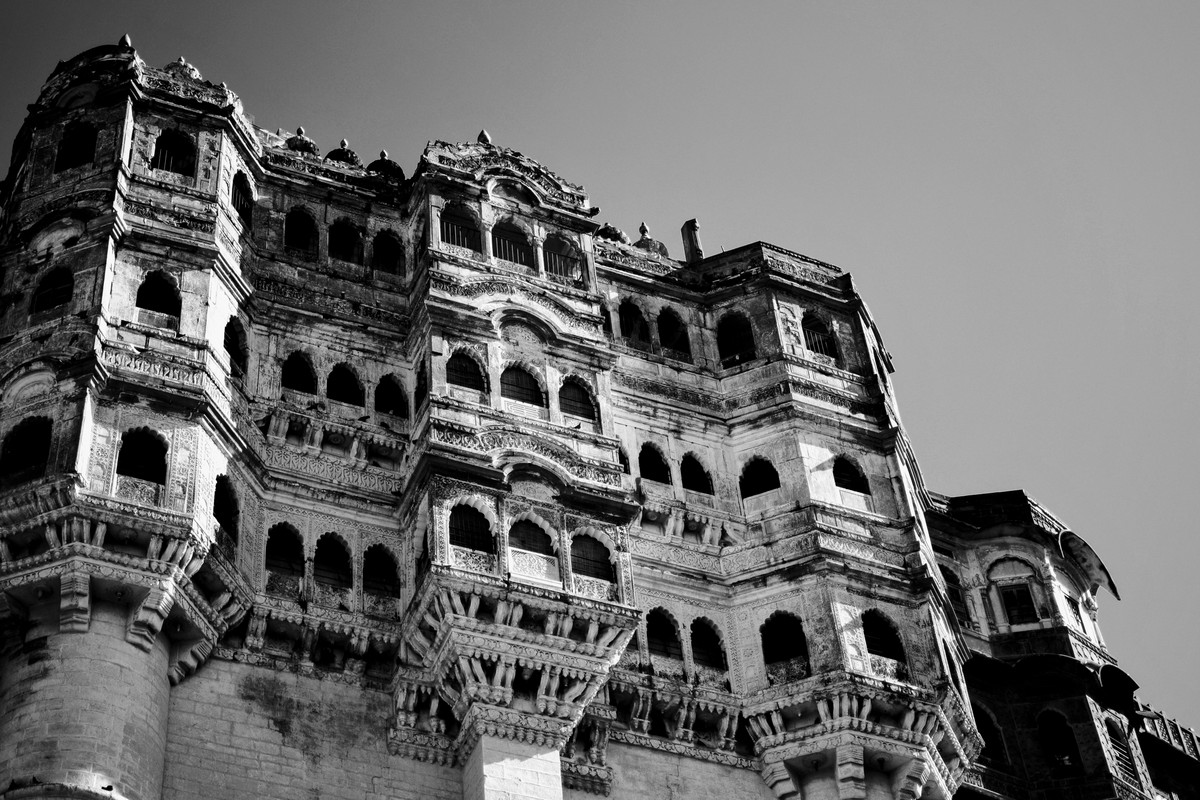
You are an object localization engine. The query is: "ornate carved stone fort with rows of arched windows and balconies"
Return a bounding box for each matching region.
[0,40,1200,800]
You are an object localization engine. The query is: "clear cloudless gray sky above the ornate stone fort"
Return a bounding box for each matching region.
[0,0,1200,724]
